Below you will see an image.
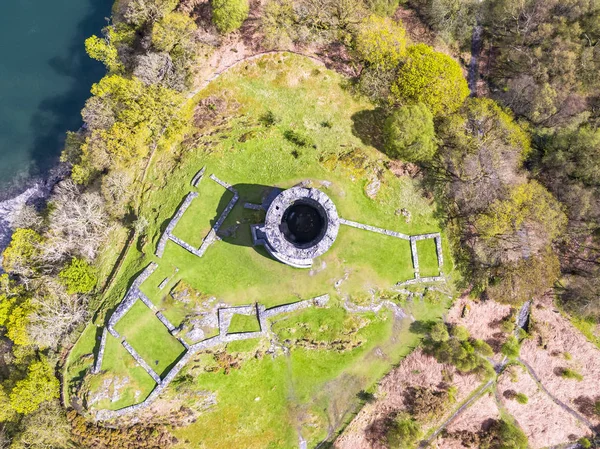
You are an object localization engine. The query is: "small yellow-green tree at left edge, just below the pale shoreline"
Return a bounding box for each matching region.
[2,229,42,275]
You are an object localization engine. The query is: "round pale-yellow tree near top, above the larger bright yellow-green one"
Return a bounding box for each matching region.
[354,15,406,70]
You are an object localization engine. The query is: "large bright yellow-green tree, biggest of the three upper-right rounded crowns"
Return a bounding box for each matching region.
[391,44,469,115]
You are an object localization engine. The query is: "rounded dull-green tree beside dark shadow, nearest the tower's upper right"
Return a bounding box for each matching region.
[384,103,437,162]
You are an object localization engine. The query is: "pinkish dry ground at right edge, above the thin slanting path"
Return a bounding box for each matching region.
[521,297,600,425]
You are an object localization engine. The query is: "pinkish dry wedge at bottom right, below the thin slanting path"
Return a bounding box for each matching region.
[498,366,590,449]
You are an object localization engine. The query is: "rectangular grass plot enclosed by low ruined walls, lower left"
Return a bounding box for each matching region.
[115,300,185,376]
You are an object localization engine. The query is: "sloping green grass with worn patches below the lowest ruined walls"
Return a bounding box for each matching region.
[174,296,447,449]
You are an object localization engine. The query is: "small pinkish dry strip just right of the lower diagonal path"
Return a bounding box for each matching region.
[431,393,500,449]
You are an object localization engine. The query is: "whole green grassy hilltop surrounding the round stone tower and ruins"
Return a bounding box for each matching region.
[67,55,456,440]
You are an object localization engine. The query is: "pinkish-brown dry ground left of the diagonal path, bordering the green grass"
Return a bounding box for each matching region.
[334,349,480,449]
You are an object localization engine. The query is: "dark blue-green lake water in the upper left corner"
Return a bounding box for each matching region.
[0,0,113,201]
